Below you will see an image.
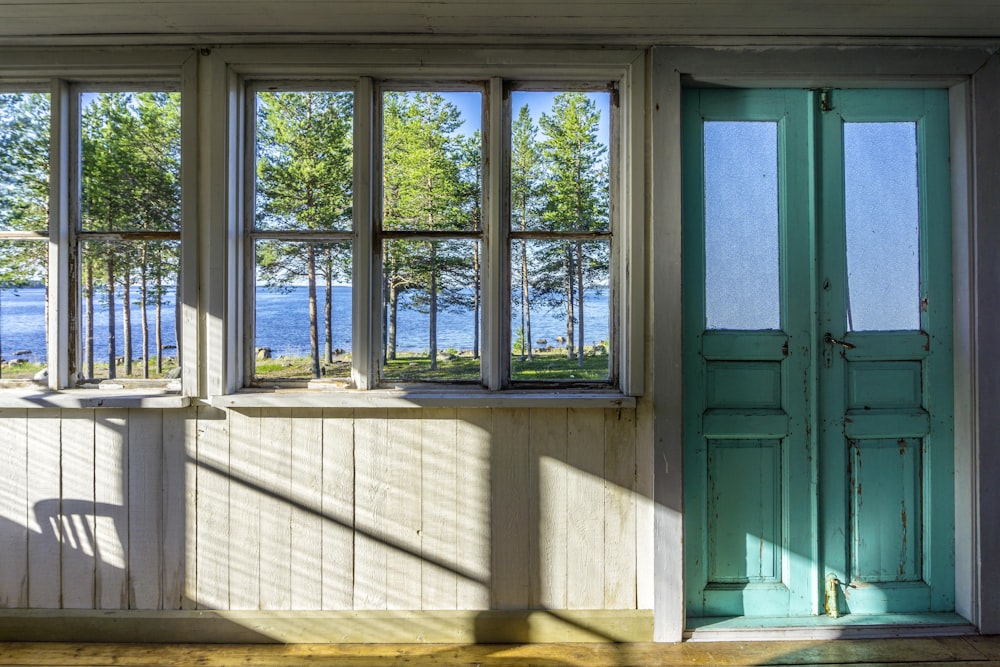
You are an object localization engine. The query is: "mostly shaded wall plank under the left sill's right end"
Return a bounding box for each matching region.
[160,408,196,609]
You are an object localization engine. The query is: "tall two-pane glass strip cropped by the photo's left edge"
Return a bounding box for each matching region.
[0,92,50,380]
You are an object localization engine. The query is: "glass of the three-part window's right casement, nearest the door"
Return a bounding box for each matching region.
[510,91,611,381]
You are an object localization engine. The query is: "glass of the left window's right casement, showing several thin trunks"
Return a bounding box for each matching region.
[77,91,181,382]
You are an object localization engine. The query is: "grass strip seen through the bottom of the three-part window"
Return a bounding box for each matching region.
[255,349,608,382]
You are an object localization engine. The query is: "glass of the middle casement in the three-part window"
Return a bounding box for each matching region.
[381,91,482,381]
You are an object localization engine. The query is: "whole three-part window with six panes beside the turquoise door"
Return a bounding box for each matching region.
[243,71,624,389]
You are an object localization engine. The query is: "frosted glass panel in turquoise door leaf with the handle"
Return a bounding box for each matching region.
[844,123,920,331]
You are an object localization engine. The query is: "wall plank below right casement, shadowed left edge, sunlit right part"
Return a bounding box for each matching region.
[529,409,567,609]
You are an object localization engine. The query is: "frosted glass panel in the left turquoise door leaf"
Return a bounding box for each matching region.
[704,121,781,329]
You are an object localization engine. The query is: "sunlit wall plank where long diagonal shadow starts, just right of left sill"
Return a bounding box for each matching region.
[192,408,231,609]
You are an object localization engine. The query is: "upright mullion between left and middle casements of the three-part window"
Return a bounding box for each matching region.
[351,77,382,389]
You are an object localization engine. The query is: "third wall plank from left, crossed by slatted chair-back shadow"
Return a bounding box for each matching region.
[59,410,97,609]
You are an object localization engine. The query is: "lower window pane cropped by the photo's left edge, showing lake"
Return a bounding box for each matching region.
[0,240,48,380]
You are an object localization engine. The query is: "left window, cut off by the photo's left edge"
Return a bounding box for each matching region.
[0,76,181,389]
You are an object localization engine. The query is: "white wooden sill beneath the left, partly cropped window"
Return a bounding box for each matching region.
[0,388,191,410]
